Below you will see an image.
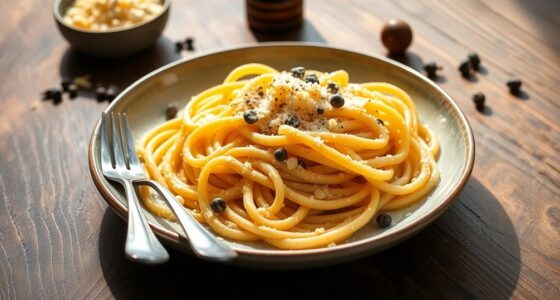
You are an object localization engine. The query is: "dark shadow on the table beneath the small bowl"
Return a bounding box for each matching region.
[59,37,181,98]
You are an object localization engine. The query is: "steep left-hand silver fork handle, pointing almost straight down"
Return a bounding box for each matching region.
[123,180,169,264]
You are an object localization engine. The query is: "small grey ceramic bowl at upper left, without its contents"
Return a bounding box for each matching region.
[53,0,171,57]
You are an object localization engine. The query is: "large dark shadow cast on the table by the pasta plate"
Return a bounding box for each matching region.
[99,178,520,299]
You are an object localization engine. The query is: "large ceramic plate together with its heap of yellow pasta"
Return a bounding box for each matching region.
[89,43,474,268]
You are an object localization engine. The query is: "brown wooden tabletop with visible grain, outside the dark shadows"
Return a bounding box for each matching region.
[0,0,560,299]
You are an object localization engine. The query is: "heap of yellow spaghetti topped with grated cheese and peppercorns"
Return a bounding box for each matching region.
[137,64,439,249]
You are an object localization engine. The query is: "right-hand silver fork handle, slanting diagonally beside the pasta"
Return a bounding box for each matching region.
[139,179,237,261]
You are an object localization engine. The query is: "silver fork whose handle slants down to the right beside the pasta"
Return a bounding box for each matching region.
[102,113,237,261]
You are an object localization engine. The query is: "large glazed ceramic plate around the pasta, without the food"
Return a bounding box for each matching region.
[88,43,475,269]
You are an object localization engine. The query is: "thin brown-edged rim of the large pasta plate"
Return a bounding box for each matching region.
[88,42,475,258]
